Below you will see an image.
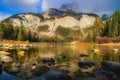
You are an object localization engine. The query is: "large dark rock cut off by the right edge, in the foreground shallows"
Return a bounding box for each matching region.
[101,61,120,76]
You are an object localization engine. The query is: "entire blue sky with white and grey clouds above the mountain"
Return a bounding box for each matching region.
[0,0,120,20]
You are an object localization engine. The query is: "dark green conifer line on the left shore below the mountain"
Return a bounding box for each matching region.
[0,22,38,41]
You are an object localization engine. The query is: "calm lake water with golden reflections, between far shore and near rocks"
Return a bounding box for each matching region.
[0,43,120,80]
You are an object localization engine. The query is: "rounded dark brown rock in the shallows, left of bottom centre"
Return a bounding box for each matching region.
[32,65,50,76]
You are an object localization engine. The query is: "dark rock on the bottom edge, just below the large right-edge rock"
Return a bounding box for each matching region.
[93,68,117,80]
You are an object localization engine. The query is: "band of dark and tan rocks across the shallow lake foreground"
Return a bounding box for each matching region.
[0,51,120,80]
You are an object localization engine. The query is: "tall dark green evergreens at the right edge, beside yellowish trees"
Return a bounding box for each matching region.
[103,10,120,37]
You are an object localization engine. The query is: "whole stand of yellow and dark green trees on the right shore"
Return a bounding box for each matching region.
[86,9,120,42]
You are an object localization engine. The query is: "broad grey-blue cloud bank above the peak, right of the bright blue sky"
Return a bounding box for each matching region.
[42,0,118,15]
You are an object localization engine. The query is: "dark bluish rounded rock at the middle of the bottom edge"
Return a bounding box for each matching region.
[41,71,70,80]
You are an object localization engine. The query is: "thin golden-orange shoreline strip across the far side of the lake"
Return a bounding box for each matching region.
[0,40,120,46]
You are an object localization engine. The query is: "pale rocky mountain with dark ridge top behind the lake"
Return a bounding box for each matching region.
[5,9,98,39]
